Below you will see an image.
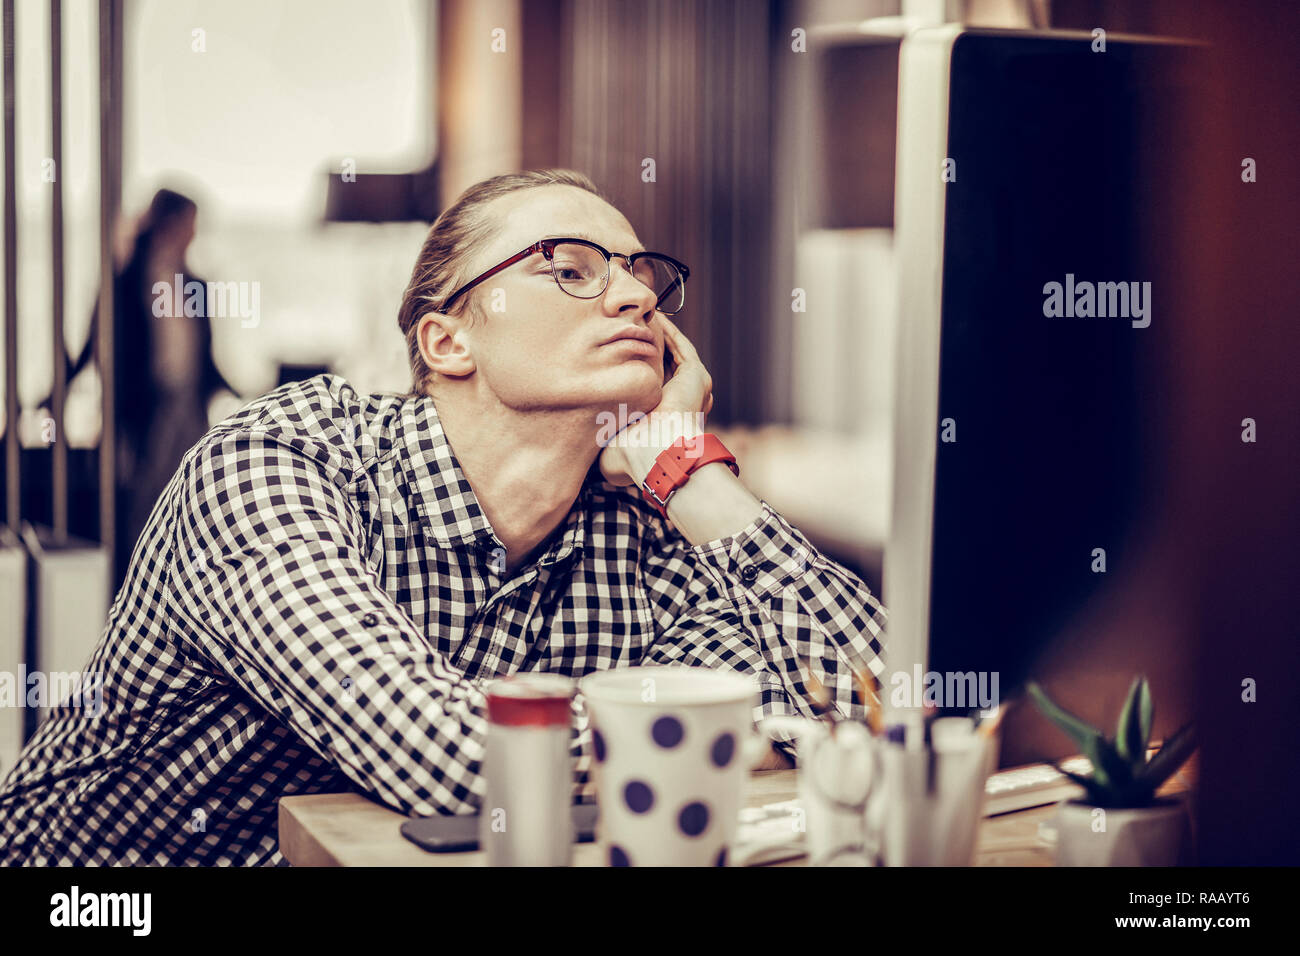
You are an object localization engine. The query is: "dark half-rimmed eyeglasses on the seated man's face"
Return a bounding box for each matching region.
[442,239,690,315]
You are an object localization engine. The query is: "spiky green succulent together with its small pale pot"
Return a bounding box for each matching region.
[1027,678,1196,866]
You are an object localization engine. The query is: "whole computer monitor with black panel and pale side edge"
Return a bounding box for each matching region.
[883,25,1197,756]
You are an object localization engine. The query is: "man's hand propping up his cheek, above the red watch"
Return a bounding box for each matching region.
[599,312,714,485]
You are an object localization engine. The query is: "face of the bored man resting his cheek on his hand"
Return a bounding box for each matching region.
[436,185,664,416]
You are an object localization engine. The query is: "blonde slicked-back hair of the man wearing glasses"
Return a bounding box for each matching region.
[398,169,605,394]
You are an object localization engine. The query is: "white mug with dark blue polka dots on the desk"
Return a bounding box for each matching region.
[579,666,767,866]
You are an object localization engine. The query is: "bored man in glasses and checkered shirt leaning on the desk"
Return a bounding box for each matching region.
[0,170,884,865]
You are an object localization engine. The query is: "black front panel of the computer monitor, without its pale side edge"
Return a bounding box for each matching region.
[930,34,1195,695]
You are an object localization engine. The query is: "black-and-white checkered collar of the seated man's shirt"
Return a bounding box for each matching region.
[393,395,590,564]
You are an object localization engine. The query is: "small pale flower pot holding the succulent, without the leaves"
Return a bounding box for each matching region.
[1056,797,1191,866]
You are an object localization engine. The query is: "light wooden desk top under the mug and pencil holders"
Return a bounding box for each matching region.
[280,770,1086,866]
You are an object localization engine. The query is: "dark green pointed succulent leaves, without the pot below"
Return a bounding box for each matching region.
[1026,676,1196,808]
